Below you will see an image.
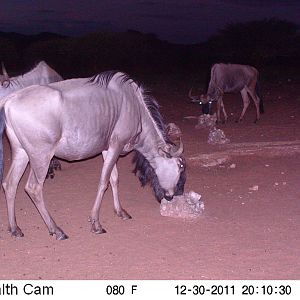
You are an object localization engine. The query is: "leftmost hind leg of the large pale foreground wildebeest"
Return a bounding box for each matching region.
[3,148,29,237]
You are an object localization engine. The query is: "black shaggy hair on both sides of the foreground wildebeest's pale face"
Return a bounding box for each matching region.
[133,151,186,202]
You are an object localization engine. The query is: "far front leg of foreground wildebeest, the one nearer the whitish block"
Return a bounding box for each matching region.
[102,151,131,220]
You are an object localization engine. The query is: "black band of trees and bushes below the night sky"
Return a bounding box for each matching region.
[0,19,300,88]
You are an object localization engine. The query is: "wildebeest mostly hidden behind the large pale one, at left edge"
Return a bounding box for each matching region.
[0,61,63,182]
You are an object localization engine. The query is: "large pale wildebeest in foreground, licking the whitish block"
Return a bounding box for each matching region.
[0,71,185,240]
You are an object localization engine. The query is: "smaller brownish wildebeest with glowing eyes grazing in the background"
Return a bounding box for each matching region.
[190,63,264,122]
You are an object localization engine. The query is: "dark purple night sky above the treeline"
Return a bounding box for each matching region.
[0,0,300,44]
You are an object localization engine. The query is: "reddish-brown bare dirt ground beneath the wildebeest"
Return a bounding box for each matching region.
[0,82,300,280]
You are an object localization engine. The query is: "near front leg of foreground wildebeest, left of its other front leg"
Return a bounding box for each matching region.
[90,147,122,234]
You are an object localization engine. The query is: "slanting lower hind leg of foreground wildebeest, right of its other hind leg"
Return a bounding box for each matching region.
[25,169,68,240]
